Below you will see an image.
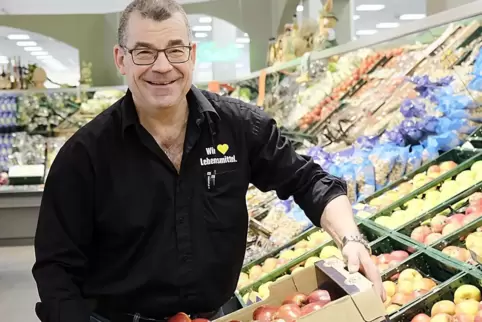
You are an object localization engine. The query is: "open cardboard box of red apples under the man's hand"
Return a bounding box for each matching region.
[216,258,386,322]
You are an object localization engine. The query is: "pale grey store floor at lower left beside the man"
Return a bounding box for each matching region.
[0,247,39,322]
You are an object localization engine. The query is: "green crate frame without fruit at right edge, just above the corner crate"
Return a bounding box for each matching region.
[427,217,482,270]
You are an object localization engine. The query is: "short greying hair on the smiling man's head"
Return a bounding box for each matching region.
[117,0,192,46]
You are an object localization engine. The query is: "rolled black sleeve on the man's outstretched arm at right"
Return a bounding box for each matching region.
[248,108,347,226]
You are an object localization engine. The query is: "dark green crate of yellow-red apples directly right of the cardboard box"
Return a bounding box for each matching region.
[382,252,462,315]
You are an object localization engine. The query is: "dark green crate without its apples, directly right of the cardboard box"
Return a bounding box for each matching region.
[382,251,466,319]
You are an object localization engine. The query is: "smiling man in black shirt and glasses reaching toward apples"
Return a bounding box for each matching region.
[33,0,383,322]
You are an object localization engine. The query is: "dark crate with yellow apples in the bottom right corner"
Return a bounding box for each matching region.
[390,272,482,322]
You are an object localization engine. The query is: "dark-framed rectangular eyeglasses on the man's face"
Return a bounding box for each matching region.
[125,46,192,66]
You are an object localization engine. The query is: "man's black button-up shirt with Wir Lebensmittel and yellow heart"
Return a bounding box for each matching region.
[33,86,346,322]
